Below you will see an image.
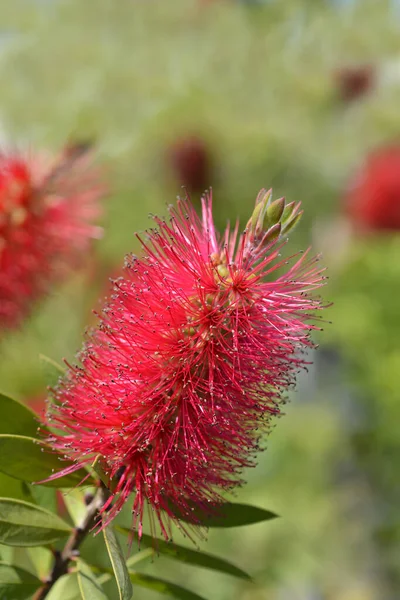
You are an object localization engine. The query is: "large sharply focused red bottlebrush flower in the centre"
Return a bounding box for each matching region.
[48,190,323,538]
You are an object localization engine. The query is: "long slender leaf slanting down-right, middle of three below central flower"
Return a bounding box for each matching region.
[117,526,251,580]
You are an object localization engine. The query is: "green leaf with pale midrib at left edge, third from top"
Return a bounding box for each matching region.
[0,498,71,547]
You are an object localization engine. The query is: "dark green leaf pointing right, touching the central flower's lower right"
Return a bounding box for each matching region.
[172,502,278,527]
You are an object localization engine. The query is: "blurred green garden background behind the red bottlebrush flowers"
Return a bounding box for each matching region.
[0,0,400,600]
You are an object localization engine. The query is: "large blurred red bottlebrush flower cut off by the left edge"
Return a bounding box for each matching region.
[0,145,103,328]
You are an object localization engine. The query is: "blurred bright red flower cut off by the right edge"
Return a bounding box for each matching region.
[345,145,400,231]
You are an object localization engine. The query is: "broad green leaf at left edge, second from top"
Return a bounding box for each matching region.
[0,434,91,488]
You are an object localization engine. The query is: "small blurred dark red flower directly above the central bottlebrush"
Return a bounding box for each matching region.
[167,135,214,194]
